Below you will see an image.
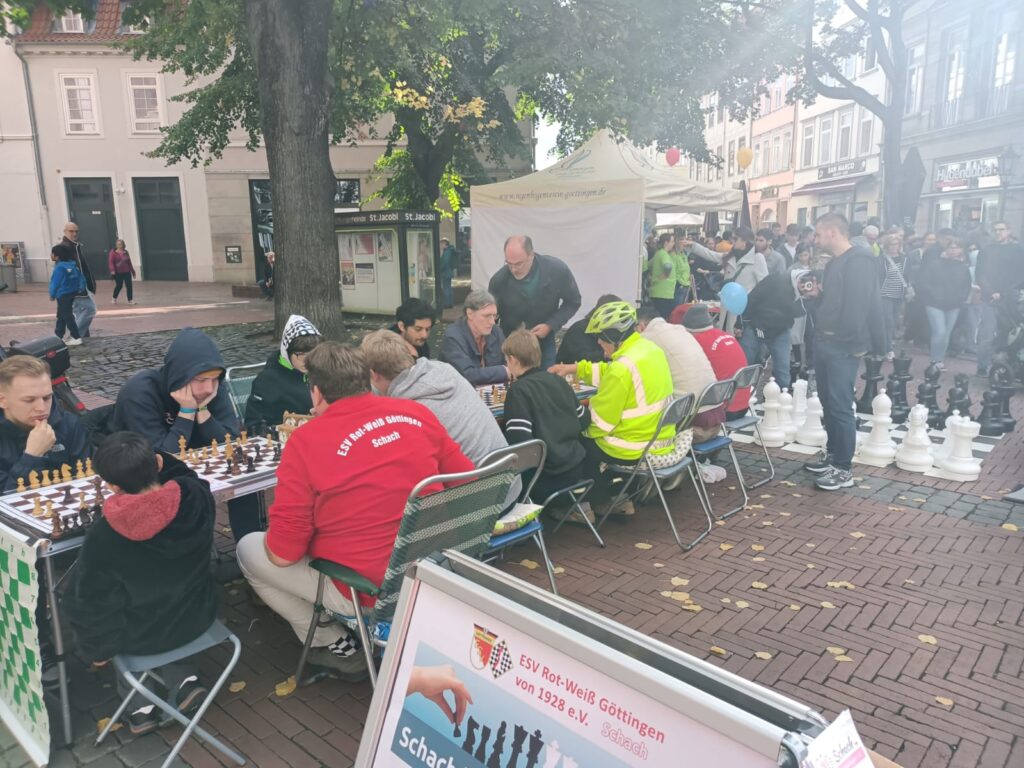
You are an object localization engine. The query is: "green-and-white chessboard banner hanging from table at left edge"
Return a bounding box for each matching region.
[0,523,50,765]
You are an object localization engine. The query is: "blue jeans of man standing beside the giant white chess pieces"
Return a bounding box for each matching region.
[814,337,860,470]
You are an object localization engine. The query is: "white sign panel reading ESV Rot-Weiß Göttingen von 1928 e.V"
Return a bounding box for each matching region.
[359,583,776,768]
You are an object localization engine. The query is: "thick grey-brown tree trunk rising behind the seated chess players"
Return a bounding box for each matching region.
[245,0,343,339]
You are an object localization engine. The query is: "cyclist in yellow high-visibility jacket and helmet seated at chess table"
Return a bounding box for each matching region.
[549,301,676,514]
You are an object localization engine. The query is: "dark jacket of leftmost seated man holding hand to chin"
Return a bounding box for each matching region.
[0,398,92,494]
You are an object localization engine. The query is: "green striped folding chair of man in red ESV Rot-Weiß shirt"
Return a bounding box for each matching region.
[295,456,517,686]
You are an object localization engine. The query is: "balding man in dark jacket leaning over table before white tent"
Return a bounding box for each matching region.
[487,234,583,368]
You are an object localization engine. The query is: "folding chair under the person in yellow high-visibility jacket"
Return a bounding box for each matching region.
[597,394,714,552]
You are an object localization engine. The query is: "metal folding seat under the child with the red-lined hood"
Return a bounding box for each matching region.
[96,621,246,768]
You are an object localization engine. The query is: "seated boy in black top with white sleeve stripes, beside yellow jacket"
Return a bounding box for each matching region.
[502,329,590,524]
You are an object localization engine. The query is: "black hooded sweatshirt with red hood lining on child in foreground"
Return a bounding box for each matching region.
[63,455,217,662]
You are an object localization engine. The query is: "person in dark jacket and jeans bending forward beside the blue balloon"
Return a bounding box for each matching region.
[739,270,813,389]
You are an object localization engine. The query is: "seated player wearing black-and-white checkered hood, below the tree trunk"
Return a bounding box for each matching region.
[246,314,321,433]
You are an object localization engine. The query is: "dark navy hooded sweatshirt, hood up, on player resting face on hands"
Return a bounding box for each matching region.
[111,328,239,454]
